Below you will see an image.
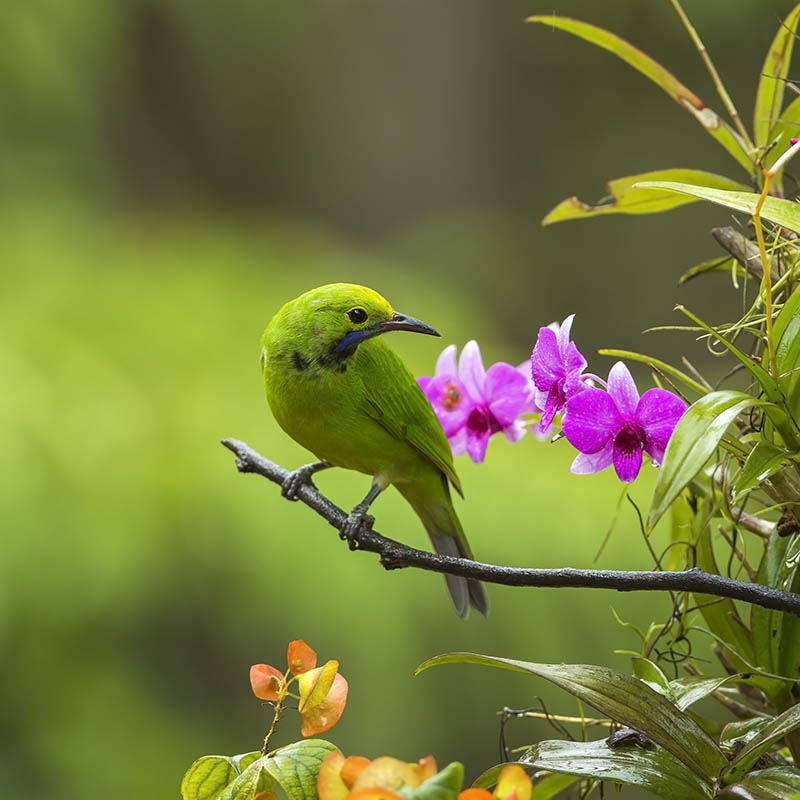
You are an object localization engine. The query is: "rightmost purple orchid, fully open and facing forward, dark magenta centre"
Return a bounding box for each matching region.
[562,361,686,483]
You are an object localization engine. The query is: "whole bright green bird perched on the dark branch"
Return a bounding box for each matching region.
[261,283,488,617]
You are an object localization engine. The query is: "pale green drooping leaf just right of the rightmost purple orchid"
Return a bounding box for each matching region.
[647,390,763,530]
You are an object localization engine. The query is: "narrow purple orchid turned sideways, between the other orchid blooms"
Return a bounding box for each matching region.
[531,314,589,432]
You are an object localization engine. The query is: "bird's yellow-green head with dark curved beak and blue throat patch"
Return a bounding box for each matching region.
[274,283,439,357]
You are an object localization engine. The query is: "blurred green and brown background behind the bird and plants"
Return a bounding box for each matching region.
[0,0,790,800]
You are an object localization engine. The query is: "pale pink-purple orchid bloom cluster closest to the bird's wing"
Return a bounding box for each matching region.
[418,340,534,464]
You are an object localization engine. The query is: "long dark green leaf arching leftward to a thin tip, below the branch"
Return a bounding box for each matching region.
[415,653,725,777]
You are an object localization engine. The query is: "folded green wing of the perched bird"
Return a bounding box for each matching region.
[358,340,464,497]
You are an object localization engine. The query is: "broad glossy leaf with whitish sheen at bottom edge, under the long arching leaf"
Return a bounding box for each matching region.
[520,740,712,800]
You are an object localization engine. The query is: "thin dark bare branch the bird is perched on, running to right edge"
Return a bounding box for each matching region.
[222,439,800,616]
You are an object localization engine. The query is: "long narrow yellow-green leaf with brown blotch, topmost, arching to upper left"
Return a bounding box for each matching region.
[527,14,754,173]
